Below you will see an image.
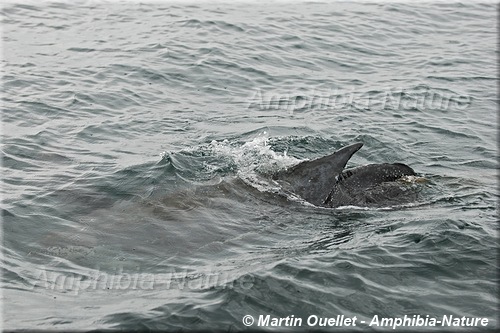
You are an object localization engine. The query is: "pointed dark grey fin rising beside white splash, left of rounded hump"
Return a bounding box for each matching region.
[273,143,363,205]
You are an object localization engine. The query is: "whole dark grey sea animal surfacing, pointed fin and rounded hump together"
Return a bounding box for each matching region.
[273,143,417,207]
